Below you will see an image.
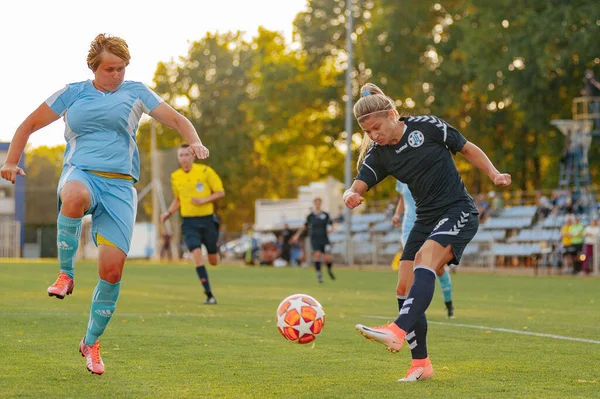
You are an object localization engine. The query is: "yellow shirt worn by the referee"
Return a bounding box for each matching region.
[171,164,225,217]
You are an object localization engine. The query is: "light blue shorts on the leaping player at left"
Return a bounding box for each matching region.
[56,166,137,254]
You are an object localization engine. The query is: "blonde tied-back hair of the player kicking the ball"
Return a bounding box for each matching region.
[353,83,399,169]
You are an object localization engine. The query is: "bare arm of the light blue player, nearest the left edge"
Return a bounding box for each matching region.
[0,103,60,184]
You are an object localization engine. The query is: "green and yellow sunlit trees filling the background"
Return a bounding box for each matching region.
[22,0,600,230]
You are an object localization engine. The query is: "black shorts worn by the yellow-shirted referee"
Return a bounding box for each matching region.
[181,215,219,255]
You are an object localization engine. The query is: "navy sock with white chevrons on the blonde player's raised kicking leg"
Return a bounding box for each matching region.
[394,266,436,333]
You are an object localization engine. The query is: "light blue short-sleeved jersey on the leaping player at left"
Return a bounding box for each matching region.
[46,80,163,181]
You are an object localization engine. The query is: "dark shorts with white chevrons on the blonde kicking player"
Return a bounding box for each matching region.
[400,204,479,265]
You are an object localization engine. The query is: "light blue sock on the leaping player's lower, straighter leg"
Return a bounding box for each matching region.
[84,279,121,345]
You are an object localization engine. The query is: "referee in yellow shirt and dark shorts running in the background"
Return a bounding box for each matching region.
[160,144,225,305]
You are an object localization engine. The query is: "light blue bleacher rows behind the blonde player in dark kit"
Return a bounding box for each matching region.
[329,206,565,266]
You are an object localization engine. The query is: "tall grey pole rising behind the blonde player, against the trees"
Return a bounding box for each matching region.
[344,0,354,265]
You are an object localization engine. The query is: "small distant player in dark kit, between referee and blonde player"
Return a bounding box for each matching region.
[292,198,335,283]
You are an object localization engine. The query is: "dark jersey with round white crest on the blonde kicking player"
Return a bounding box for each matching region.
[356,115,477,223]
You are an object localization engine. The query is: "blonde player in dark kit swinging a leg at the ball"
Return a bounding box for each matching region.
[344,84,511,382]
